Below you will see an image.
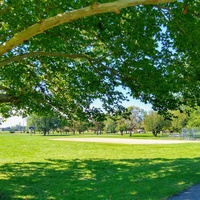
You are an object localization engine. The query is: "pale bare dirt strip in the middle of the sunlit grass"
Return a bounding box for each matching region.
[50,138,200,144]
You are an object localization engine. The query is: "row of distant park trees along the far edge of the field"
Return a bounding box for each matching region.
[27,106,200,136]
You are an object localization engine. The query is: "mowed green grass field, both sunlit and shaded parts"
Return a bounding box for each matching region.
[0,133,200,200]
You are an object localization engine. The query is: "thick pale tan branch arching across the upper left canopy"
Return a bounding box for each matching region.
[0,0,175,55]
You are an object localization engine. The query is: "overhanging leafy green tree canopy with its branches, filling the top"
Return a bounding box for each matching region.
[0,0,200,118]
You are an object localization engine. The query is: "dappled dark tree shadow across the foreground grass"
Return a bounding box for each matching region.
[0,158,200,200]
